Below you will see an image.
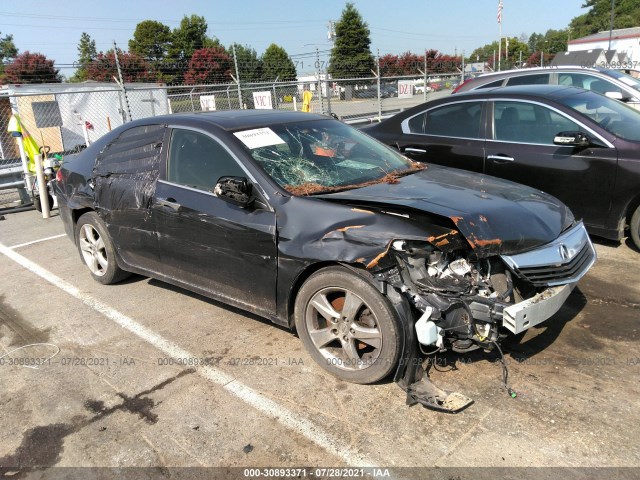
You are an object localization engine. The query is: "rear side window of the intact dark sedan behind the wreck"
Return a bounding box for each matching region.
[409,102,483,138]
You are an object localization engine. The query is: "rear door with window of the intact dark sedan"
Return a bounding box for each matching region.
[397,100,485,172]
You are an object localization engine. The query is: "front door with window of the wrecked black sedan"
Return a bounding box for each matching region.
[152,128,277,314]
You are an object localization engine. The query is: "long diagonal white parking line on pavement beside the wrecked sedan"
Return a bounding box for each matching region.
[0,243,376,467]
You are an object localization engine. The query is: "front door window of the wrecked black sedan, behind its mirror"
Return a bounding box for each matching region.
[167,129,246,191]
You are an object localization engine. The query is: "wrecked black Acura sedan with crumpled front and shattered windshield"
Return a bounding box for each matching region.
[55,110,595,411]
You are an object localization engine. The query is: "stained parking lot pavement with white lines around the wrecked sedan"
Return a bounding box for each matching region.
[0,211,640,478]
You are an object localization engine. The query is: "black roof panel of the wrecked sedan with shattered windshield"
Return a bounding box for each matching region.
[126,109,331,131]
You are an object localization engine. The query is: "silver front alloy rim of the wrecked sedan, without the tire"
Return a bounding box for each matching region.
[305,287,383,371]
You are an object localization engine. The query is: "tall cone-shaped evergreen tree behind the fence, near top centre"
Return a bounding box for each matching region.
[329,3,375,79]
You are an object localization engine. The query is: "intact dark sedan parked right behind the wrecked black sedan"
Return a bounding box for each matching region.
[363,85,640,248]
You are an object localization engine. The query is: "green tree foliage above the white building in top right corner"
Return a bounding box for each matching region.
[569,0,640,38]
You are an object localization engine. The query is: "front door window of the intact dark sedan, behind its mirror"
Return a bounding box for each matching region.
[493,102,582,145]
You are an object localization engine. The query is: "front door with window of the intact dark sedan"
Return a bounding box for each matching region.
[486,100,617,226]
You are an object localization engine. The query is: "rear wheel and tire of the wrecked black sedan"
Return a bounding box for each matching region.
[76,212,130,285]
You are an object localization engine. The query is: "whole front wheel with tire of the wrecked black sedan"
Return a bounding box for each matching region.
[294,267,400,384]
